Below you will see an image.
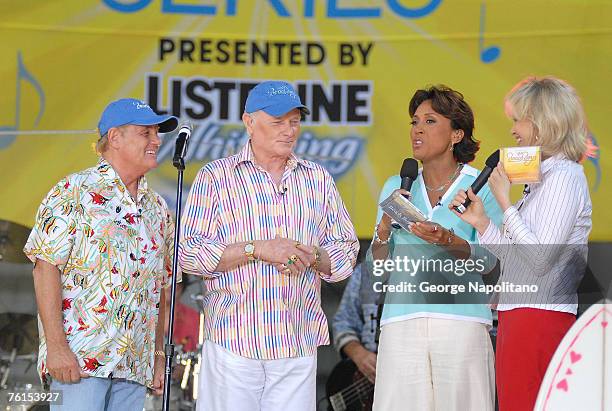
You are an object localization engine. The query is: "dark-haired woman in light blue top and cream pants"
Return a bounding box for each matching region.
[368,86,501,411]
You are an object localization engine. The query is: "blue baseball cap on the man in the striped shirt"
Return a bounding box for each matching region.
[244,81,310,117]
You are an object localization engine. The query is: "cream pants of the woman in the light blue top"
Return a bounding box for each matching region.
[373,318,495,411]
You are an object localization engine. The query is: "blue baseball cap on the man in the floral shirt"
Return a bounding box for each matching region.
[98,98,178,137]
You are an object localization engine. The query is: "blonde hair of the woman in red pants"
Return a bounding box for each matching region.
[506,76,588,161]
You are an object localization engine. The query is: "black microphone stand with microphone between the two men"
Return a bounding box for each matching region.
[163,153,185,411]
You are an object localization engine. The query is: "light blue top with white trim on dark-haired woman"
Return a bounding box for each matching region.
[367,164,503,325]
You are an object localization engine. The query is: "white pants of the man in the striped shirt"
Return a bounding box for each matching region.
[197,341,317,411]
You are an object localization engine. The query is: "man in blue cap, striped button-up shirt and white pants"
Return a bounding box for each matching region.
[179,81,359,411]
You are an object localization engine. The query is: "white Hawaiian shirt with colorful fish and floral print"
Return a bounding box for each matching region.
[24,159,174,386]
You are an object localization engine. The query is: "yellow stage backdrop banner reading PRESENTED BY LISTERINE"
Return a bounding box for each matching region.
[0,0,612,240]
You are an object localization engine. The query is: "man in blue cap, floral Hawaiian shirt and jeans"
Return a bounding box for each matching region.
[24,99,178,411]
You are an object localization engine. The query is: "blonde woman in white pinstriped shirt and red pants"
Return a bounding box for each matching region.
[449,77,591,411]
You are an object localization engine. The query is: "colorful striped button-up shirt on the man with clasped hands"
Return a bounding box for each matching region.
[179,143,359,359]
